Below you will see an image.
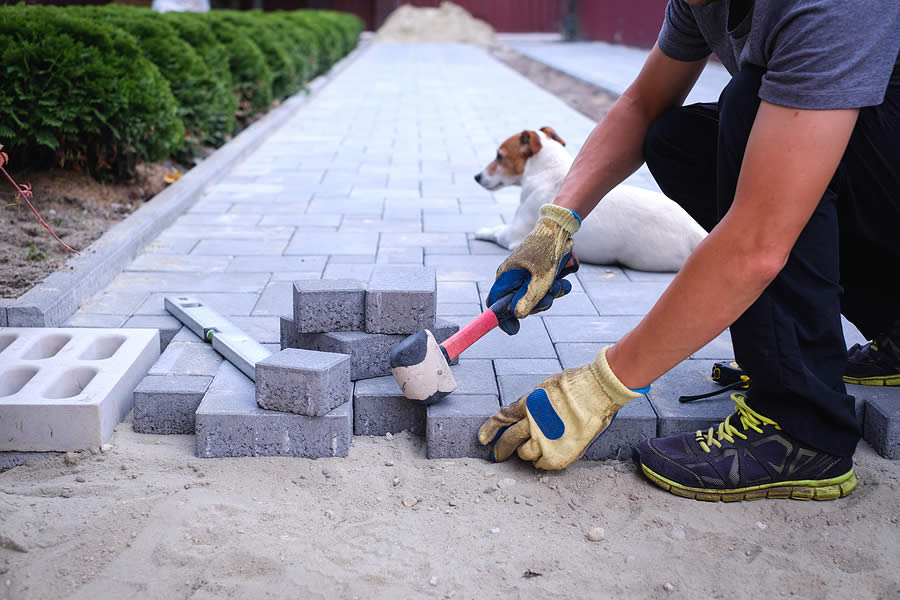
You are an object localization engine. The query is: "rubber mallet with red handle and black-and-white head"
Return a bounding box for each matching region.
[391,254,579,404]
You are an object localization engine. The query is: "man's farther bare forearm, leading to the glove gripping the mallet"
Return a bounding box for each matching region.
[554,46,706,218]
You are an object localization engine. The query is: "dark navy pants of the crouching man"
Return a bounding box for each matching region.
[644,68,900,456]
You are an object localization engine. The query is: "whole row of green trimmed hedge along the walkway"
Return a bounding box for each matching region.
[0,4,362,178]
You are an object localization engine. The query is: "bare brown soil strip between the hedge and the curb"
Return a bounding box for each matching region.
[0,161,176,298]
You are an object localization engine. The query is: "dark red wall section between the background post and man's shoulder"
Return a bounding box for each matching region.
[577,0,666,48]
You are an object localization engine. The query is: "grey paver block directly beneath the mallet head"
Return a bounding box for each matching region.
[353,375,425,435]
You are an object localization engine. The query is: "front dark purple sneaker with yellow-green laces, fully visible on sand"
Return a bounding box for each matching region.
[636,394,856,502]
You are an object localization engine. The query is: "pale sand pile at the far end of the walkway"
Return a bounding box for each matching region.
[375,2,497,46]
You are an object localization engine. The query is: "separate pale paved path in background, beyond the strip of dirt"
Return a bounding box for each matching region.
[510,42,731,104]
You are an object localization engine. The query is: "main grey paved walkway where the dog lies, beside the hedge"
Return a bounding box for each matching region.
[71,45,864,432]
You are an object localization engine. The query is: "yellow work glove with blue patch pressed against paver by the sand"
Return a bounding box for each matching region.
[478,346,646,470]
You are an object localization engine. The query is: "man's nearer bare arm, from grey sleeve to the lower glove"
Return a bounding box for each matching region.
[607,102,859,389]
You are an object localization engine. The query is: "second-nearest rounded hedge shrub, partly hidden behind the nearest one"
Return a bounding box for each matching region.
[68,4,216,155]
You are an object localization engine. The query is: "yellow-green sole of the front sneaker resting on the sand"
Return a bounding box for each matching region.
[641,465,856,502]
